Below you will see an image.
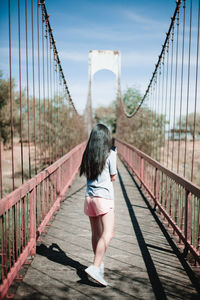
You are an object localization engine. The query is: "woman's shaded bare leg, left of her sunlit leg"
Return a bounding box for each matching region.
[90,217,103,254]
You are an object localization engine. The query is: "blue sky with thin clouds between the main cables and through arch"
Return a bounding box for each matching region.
[0,0,197,113]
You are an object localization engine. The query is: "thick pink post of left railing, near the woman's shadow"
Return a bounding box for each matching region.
[29,187,36,256]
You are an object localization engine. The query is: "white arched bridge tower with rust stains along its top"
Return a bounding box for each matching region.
[85,50,121,134]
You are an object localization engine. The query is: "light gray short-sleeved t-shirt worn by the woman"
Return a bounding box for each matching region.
[86,150,117,199]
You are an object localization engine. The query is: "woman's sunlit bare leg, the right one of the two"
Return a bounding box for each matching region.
[94,210,114,267]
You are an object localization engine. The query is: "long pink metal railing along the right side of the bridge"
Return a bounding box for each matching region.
[115,140,200,264]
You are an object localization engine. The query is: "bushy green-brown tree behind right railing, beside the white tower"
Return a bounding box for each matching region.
[117,88,166,159]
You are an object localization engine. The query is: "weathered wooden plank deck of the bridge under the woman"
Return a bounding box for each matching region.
[14,162,199,300]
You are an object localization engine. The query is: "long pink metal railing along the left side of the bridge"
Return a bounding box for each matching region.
[0,142,85,299]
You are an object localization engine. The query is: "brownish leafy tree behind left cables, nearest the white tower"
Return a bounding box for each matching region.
[26,95,86,164]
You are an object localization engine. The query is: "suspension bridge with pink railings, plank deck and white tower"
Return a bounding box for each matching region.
[0,0,200,299]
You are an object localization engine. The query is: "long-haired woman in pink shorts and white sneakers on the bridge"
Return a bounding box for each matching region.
[80,124,117,286]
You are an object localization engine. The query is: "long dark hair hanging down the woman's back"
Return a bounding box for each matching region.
[80,124,111,180]
